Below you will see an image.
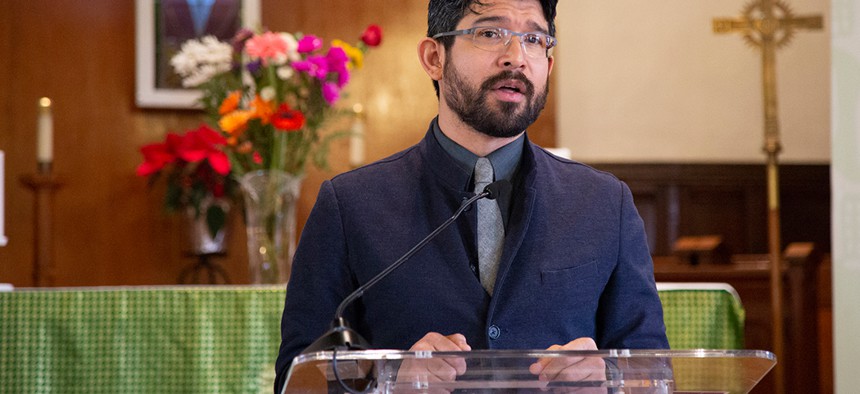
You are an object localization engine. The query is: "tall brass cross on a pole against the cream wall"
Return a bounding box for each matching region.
[713,0,823,393]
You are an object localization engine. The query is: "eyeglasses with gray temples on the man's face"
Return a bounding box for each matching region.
[433,27,558,58]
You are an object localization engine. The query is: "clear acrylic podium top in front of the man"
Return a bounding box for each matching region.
[282,350,776,394]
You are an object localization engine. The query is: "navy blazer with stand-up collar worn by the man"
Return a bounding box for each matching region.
[276,124,669,387]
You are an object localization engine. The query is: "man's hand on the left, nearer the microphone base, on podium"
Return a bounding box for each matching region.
[397,332,472,390]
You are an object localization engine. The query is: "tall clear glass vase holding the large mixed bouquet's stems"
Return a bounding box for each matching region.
[239,170,303,284]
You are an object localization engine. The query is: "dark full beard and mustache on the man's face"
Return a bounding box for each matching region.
[444,58,549,138]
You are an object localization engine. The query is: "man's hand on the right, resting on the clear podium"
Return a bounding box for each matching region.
[529,338,606,392]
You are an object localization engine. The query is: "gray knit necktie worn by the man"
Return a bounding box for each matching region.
[475,157,505,295]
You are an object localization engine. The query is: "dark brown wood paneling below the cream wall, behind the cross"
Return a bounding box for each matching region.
[595,163,830,255]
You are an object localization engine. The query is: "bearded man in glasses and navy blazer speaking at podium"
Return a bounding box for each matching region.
[276,0,668,389]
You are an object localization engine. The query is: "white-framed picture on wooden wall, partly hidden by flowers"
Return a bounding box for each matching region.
[135,0,260,108]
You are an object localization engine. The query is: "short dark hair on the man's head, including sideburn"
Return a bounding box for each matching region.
[427,0,558,97]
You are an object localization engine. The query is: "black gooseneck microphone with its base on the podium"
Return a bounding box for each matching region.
[302,179,511,354]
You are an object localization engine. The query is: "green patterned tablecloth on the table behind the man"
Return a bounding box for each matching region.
[0,286,743,393]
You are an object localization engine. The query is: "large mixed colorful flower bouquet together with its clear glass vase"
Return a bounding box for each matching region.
[158,25,382,283]
